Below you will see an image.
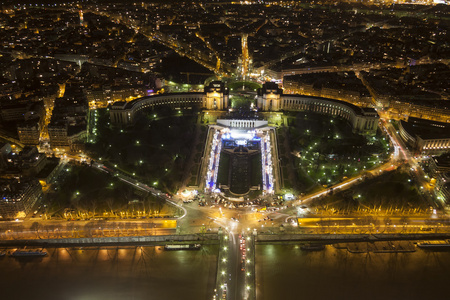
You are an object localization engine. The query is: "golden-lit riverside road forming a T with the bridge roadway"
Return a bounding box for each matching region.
[2,202,450,300]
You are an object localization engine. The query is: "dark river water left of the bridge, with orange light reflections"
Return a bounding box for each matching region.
[0,246,218,300]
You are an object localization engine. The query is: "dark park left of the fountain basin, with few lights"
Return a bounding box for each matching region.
[88,108,206,193]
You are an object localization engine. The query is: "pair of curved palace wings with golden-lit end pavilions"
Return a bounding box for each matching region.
[110,81,379,134]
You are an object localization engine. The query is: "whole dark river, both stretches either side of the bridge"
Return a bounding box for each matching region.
[0,245,450,300]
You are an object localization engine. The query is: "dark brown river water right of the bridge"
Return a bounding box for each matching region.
[256,245,450,300]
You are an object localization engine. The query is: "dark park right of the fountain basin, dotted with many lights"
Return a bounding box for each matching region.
[284,112,390,191]
